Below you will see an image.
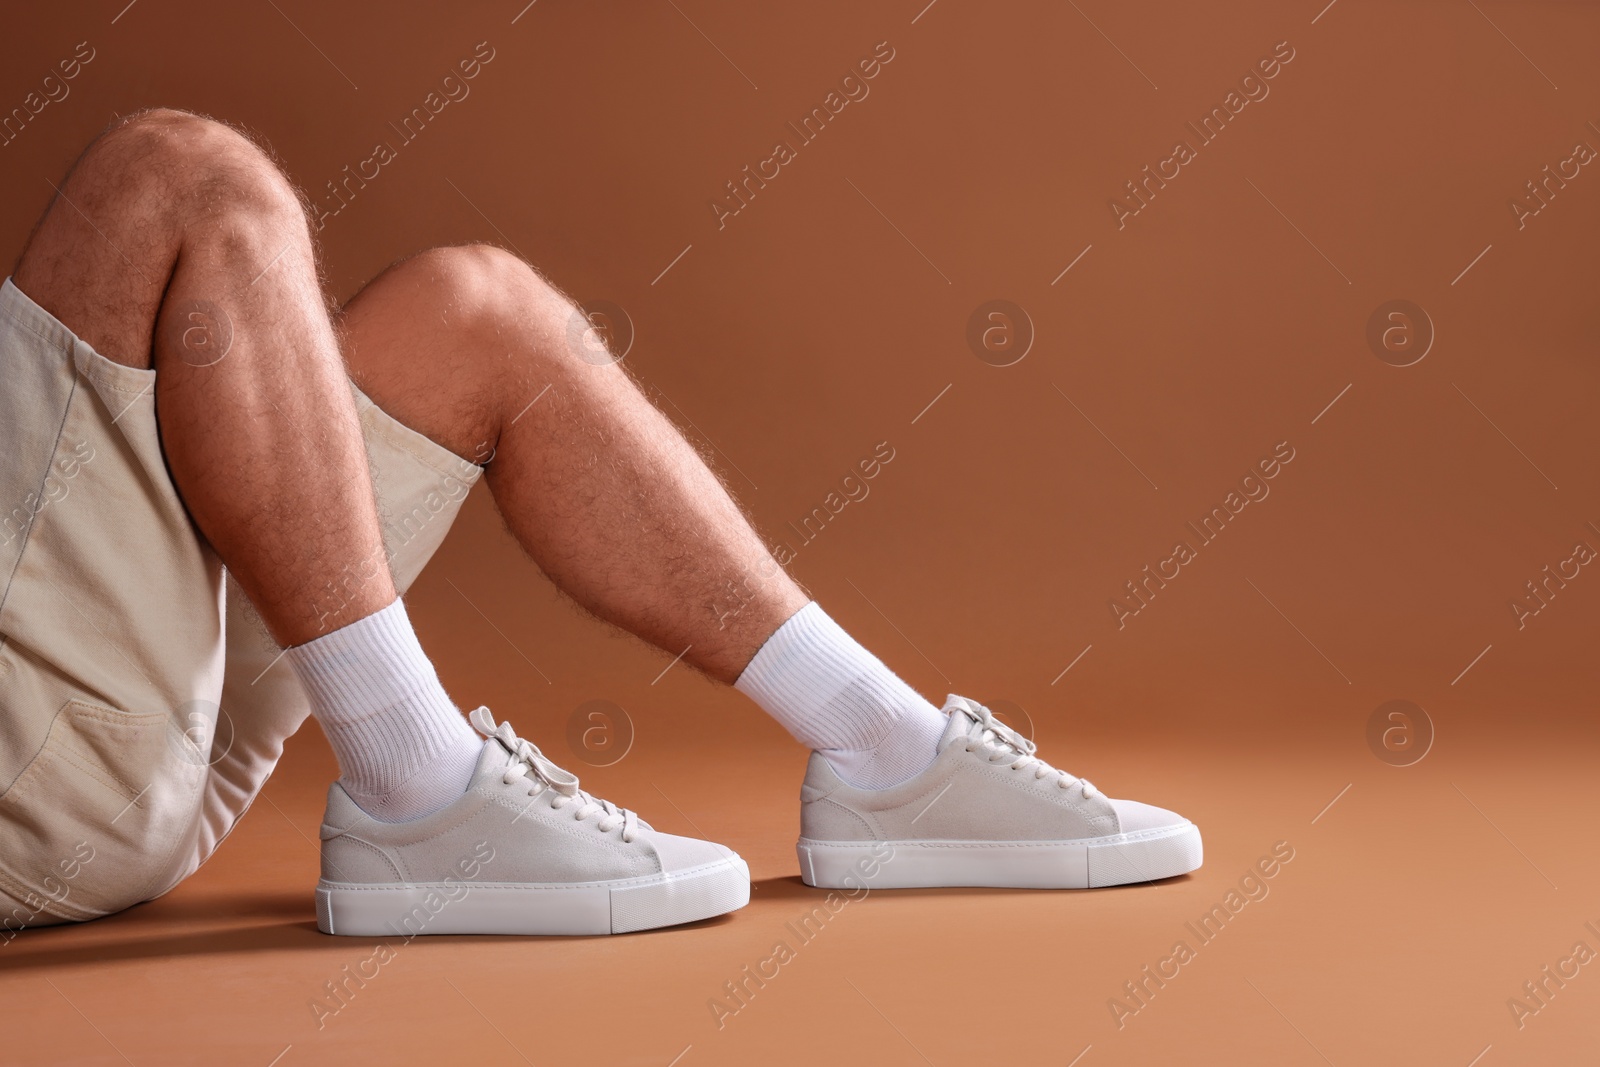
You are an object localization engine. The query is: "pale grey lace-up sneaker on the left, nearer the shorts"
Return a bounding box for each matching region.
[317,707,750,937]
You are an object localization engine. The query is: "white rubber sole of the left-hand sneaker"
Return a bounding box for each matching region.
[317,856,750,939]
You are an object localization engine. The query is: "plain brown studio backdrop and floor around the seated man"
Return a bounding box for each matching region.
[0,0,1600,1067]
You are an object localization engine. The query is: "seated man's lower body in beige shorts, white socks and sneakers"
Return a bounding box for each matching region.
[0,110,1202,937]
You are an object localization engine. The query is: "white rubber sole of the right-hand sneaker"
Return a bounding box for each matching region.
[795,822,1205,889]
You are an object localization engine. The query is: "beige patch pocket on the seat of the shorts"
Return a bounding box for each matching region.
[0,701,205,920]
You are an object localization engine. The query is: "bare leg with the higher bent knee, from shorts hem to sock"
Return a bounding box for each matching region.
[14,110,395,645]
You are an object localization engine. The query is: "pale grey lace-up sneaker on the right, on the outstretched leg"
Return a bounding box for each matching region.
[797,694,1202,889]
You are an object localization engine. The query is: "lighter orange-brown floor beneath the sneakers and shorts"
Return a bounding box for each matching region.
[0,697,1600,1067]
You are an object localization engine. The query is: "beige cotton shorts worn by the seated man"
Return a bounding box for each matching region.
[0,280,480,941]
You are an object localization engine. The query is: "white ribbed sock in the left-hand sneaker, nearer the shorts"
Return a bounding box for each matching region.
[286,600,483,822]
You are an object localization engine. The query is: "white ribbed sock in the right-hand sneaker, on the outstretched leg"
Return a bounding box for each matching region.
[733,600,947,789]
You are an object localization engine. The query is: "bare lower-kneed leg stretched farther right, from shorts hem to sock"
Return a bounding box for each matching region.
[341,245,808,681]
